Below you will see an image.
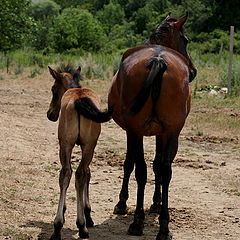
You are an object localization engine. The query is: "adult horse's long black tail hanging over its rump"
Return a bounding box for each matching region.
[128,56,167,115]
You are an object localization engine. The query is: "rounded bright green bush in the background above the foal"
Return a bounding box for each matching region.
[52,8,106,52]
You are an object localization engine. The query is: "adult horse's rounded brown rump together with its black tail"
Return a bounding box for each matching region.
[109,45,189,135]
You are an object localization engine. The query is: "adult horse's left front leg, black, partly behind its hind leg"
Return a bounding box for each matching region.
[113,130,134,214]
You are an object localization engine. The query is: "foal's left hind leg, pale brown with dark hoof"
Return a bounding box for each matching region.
[51,143,73,240]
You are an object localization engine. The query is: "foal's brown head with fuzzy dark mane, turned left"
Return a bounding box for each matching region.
[47,66,82,122]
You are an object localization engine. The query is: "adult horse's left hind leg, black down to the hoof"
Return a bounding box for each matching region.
[127,132,147,236]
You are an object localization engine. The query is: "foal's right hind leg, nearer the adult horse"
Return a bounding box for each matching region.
[75,145,95,238]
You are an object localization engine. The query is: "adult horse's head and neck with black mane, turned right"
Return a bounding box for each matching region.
[148,13,197,81]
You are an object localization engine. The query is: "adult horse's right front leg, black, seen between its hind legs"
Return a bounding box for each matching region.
[150,136,163,213]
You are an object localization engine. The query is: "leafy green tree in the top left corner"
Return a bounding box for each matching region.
[0,0,34,52]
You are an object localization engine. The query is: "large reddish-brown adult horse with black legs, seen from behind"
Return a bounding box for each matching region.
[108,14,197,240]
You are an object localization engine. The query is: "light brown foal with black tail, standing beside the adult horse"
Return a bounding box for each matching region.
[47,67,111,239]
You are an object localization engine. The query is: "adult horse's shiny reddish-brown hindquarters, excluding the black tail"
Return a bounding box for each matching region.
[109,45,190,136]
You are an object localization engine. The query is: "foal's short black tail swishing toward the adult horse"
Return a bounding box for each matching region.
[74,97,113,123]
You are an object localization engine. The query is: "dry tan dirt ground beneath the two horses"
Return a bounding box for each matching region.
[0,71,240,240]
